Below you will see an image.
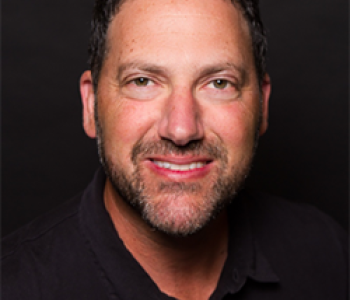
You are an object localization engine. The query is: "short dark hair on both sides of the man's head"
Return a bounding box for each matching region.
[89,0,267,92]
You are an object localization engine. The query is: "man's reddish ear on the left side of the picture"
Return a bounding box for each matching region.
[80,71,96,138]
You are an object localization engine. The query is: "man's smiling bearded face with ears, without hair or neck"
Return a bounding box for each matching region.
[82,0,269,236]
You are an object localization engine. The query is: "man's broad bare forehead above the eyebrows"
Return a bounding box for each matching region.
[107,0,252,70]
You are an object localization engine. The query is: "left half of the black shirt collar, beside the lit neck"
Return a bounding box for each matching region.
[80,168,170,300]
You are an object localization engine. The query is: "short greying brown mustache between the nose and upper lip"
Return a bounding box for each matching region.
[131,140,227,164]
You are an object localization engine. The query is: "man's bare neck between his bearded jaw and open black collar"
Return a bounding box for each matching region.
[104,180,228,300]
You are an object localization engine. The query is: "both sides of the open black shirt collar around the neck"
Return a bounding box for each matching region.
[79,168,278,300]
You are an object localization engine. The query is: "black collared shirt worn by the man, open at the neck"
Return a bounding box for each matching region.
[0,170,350,300]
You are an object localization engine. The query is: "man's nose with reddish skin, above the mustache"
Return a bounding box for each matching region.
[158,89,204,146]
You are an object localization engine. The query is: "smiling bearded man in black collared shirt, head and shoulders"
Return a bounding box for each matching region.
[0,0,350,299]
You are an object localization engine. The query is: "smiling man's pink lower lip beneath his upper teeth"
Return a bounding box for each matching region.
[147,160,212,180]
